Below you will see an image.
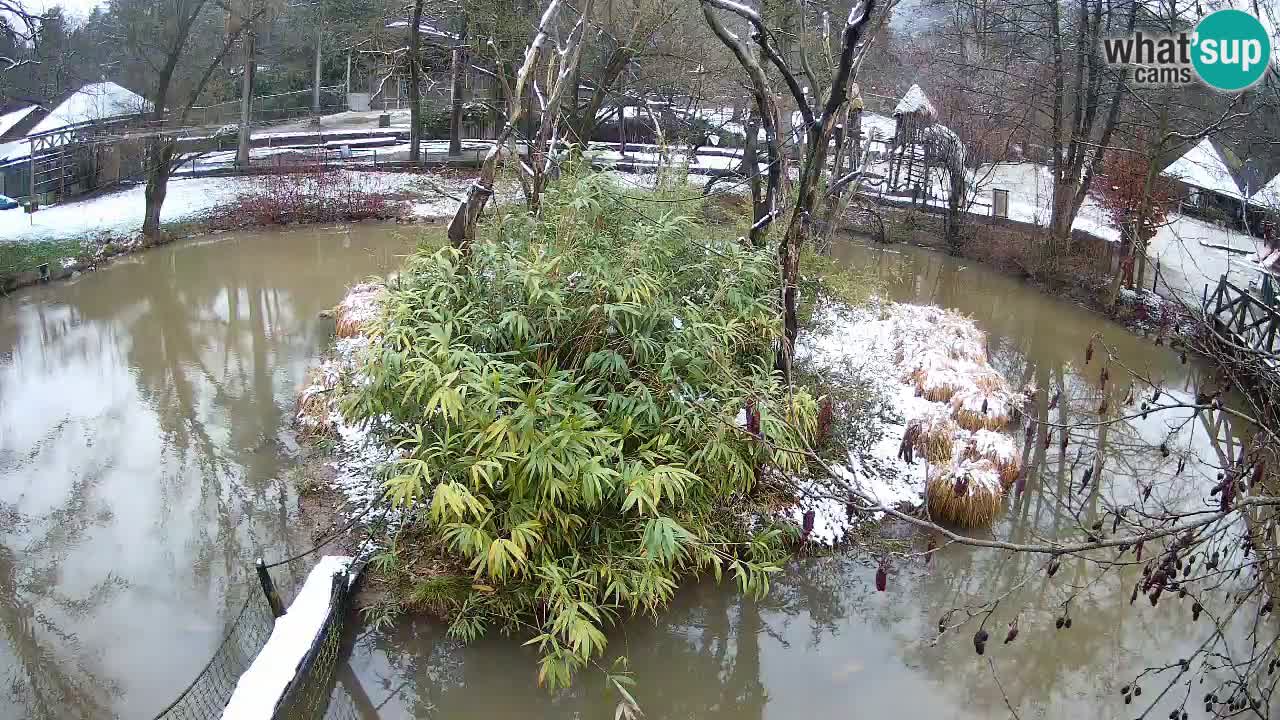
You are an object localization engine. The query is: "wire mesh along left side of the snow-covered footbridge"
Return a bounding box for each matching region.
[156,592,275,720]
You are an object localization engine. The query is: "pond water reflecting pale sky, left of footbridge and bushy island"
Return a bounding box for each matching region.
[0,227,411,719]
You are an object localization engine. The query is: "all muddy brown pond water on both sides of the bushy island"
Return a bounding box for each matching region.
[0,225,1249,719]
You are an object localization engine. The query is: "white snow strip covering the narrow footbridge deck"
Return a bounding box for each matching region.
[223,555,351,720]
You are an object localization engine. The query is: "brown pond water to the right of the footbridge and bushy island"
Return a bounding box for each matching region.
[337,237,1240,719]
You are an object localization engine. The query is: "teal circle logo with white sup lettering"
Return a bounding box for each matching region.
[1192,10,1271,92]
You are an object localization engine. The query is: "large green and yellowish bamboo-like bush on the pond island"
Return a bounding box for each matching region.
[342,174,817,687]
